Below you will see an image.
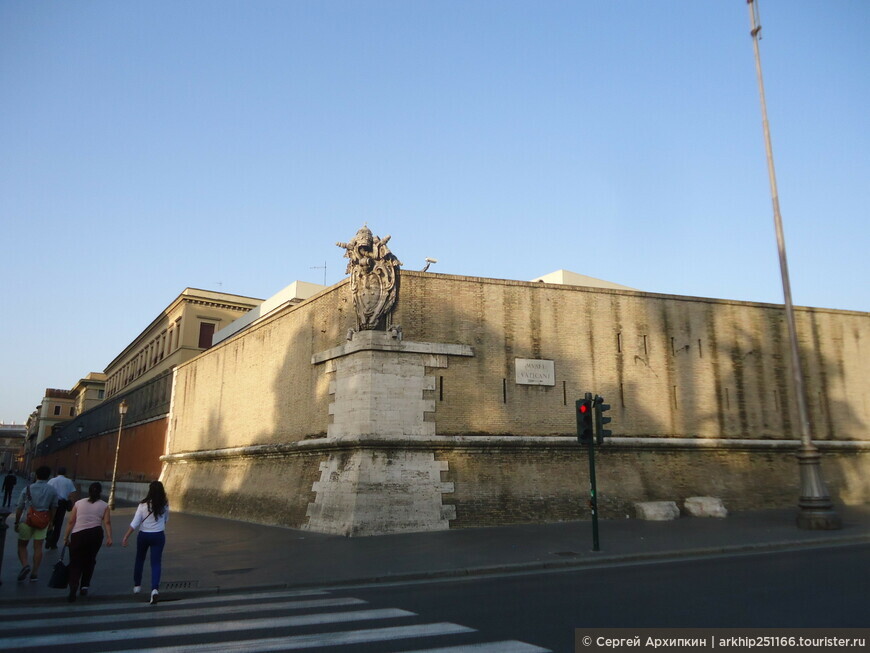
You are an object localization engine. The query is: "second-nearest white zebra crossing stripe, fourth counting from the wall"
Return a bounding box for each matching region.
[136,622,480,653]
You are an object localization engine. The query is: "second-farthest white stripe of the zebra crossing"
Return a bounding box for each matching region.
[4,597,367,630]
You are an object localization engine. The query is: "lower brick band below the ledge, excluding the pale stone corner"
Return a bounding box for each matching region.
[164,440,870,532]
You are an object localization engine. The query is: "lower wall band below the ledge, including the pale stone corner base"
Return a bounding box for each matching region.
[160,436,870,535]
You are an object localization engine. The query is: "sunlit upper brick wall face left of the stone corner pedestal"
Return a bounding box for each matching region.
[170,283,355,452]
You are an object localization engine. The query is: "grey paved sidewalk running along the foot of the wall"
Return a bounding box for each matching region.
[0,482,870,604]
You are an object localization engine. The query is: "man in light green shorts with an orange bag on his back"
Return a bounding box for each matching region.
[15,465,57,582]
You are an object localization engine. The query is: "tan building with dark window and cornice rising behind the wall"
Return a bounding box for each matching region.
[105,288,263,399]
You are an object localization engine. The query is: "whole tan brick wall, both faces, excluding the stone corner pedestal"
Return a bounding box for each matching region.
[164,272,870,527]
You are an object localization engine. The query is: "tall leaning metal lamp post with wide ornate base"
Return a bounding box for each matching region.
[747,0,843,530]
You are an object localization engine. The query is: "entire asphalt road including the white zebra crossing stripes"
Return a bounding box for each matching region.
[0,544,870,653]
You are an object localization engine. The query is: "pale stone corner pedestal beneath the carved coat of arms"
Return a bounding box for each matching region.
[307,330,473,535]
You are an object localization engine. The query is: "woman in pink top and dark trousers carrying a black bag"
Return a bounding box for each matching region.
[63,483,112,603]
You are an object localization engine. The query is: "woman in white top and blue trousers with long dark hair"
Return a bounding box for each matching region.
[121,481,169,605]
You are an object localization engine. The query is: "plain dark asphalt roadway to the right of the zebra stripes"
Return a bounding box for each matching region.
[354,544,870,652]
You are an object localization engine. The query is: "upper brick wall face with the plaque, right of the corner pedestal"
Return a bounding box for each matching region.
[394,272,870,440]
